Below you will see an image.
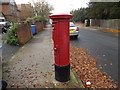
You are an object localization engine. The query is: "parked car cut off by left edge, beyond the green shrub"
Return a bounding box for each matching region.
[0,17,11,33]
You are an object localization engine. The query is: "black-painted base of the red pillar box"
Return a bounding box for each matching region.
[55,64,70,82]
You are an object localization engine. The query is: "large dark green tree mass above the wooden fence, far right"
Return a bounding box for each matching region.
[86,2,120,19]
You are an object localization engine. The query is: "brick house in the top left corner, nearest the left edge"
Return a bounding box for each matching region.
[0,0,20,21]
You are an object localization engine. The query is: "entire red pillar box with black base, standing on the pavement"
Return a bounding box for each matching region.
[49,14,72,82]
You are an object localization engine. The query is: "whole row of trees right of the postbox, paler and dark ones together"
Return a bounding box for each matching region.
[70,2,120,22]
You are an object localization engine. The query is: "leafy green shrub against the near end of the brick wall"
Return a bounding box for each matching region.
[7,25,19,45]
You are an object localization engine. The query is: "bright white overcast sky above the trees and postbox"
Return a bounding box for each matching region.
[15,0,89,14]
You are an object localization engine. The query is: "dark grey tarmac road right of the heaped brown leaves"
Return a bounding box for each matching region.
[70,27,118,84]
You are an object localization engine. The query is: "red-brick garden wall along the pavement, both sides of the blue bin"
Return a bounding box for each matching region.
[17,22,46,44]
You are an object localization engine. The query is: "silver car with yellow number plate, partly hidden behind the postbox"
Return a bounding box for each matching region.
[70,22,79,38]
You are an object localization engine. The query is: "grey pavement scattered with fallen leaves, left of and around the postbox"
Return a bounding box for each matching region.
[3,25,84,88]
